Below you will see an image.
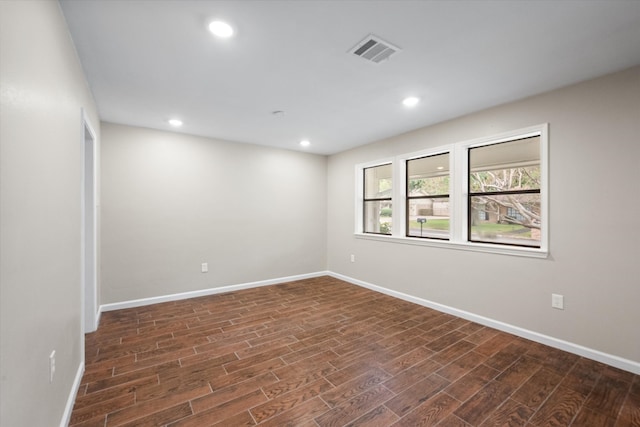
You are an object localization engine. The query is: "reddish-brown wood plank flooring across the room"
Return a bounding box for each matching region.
[70,277,640,427]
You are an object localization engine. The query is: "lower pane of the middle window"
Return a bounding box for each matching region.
[407,197,449,239]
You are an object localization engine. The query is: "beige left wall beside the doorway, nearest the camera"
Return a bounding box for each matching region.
[0,1,99,427]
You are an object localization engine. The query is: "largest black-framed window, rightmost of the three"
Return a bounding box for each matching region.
[468,136,541,247]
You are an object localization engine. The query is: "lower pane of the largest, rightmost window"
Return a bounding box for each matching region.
[470,193,540,247]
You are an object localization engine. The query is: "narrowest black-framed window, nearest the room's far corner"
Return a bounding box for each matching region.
[362,164,393,234]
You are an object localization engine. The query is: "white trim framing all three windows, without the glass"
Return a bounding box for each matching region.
[355,123,549,258]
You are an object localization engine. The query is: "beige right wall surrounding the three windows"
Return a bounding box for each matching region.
[327,67,640,363]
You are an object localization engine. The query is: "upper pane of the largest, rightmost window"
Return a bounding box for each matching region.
[469,136,540,193]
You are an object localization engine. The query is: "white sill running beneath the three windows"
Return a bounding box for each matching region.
[354,233,549,258]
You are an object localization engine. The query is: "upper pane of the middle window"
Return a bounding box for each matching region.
[407,153,449,196]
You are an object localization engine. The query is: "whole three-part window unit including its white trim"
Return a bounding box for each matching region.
[355,124,549,258]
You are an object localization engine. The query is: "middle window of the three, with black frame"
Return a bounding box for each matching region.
[406,153,449,240]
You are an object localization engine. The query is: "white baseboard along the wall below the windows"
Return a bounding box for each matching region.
[327,272,640,375]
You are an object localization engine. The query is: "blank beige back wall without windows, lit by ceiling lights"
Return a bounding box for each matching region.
[101,123,327,304]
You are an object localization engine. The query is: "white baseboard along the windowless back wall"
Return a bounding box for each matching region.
[100,271,329,313]
